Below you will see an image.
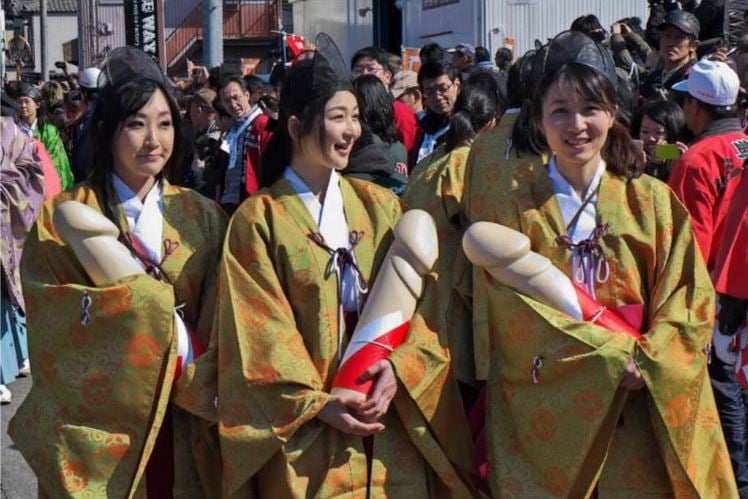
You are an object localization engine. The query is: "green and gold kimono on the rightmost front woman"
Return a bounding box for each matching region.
[476,172,737,497]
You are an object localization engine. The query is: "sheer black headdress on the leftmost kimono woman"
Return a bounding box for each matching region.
[99,47,170,89]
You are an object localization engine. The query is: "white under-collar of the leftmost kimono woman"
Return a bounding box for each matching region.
[112,174,164,262]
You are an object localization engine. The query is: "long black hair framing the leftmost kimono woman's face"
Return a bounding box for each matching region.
[88,78,184,198]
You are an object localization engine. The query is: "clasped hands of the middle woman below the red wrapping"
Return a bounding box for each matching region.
[317,360,397,437]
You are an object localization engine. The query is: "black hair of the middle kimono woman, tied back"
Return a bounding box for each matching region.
[260,55,353,187]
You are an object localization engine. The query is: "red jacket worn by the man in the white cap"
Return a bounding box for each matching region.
[668,118,748,271]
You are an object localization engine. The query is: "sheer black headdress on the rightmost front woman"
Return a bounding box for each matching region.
[533,31,618,87]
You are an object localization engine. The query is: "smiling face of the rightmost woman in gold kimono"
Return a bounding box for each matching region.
[540,83,615,174]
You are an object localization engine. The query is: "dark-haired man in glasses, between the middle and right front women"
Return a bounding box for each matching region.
[416,60,460,163]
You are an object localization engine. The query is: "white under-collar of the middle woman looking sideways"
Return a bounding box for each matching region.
[283,167,351,252]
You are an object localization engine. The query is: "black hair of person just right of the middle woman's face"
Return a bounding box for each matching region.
[353,74,400,144]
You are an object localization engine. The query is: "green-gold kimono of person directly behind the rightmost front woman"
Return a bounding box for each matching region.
[458,112,544,380]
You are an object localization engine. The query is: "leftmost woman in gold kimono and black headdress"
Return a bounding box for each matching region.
[10,48,226,499]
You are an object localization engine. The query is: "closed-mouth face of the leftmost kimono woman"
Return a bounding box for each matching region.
[113,89,174,190]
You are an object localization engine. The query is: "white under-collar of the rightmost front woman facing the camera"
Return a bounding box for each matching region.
[548,156,605,242]
